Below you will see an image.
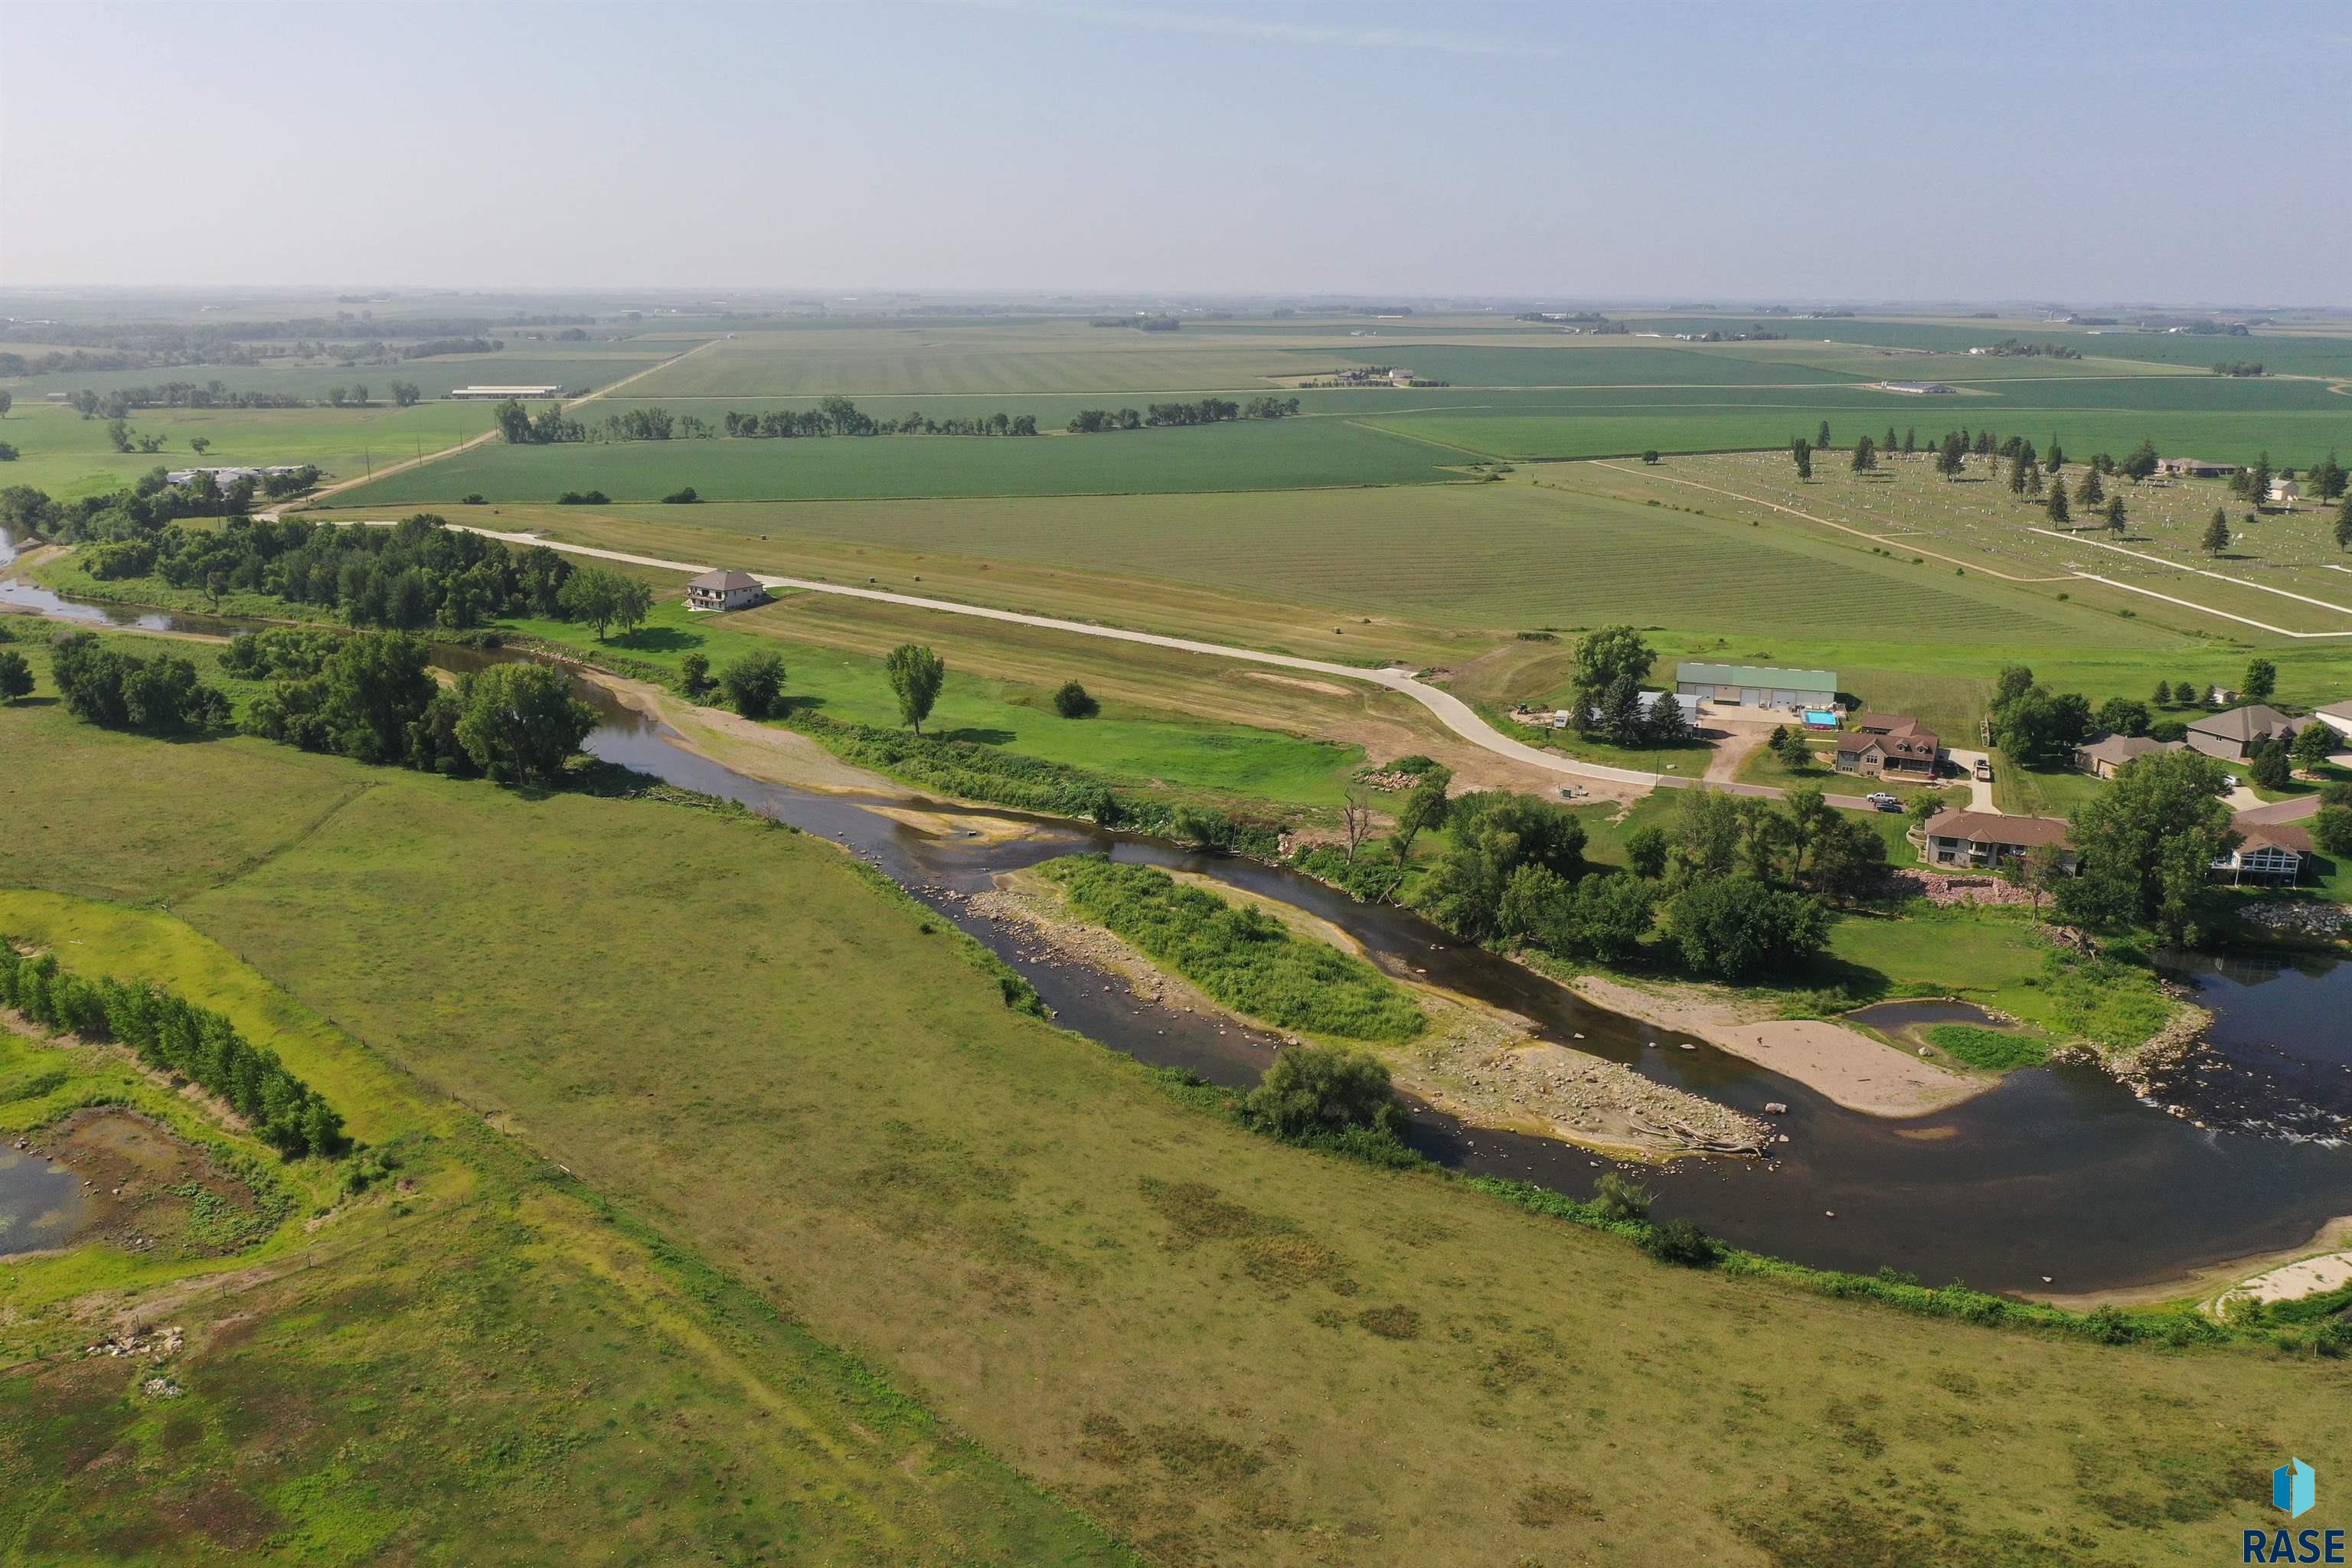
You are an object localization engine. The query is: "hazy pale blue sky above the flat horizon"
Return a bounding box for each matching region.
[0,0,2352,303]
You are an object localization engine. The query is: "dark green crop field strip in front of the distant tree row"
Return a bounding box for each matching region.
[312,411,1461,508]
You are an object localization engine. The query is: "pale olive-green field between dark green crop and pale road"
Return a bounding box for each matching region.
[357,482,2176,658]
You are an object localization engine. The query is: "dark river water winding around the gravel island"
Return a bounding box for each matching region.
[0,533,2352,1293]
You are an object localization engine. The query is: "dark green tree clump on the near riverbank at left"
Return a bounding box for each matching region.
[50,630,595,782]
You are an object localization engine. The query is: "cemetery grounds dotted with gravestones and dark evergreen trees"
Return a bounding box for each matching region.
[1547,452,2352,637]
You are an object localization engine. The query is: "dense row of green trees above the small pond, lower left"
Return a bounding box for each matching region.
[0,936,351,1159]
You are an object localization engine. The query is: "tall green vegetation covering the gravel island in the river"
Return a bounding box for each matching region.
[1040,856,1430,1044]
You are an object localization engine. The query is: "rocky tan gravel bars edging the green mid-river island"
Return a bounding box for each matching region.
[969,872,1769,1159]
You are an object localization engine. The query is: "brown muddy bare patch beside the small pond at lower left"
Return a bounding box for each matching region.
[26,1107,280,1258]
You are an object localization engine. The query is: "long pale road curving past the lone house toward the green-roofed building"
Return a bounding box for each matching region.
[332,518,1900,811]
